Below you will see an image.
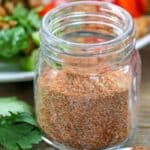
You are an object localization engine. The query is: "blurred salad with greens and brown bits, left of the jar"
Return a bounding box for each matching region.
[0,0,41,71]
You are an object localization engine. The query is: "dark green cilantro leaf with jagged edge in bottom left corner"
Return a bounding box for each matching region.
[0,123,41,150]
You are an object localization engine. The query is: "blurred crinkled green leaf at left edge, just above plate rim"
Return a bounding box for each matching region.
[0,27,28,58]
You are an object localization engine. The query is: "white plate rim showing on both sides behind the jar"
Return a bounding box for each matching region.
[0,34,150,82]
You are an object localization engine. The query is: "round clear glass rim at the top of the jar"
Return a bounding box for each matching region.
[42,0,134,54]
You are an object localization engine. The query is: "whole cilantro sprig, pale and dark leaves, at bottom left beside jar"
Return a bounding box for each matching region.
[0,97,42,150]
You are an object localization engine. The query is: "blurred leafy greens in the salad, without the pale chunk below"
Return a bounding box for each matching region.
[0,4,41,58]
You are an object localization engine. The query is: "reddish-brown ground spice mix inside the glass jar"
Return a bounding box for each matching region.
[37,68,130,150]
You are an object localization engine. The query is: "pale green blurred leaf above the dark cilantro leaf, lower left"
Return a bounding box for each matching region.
[0,97,31,116]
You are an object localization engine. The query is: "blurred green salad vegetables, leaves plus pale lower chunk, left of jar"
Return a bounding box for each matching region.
[0,4,41,71]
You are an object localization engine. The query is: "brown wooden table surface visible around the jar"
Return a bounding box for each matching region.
[0,46,150,150]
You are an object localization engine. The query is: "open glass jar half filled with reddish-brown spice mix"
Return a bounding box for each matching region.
[35,1,140,150]
